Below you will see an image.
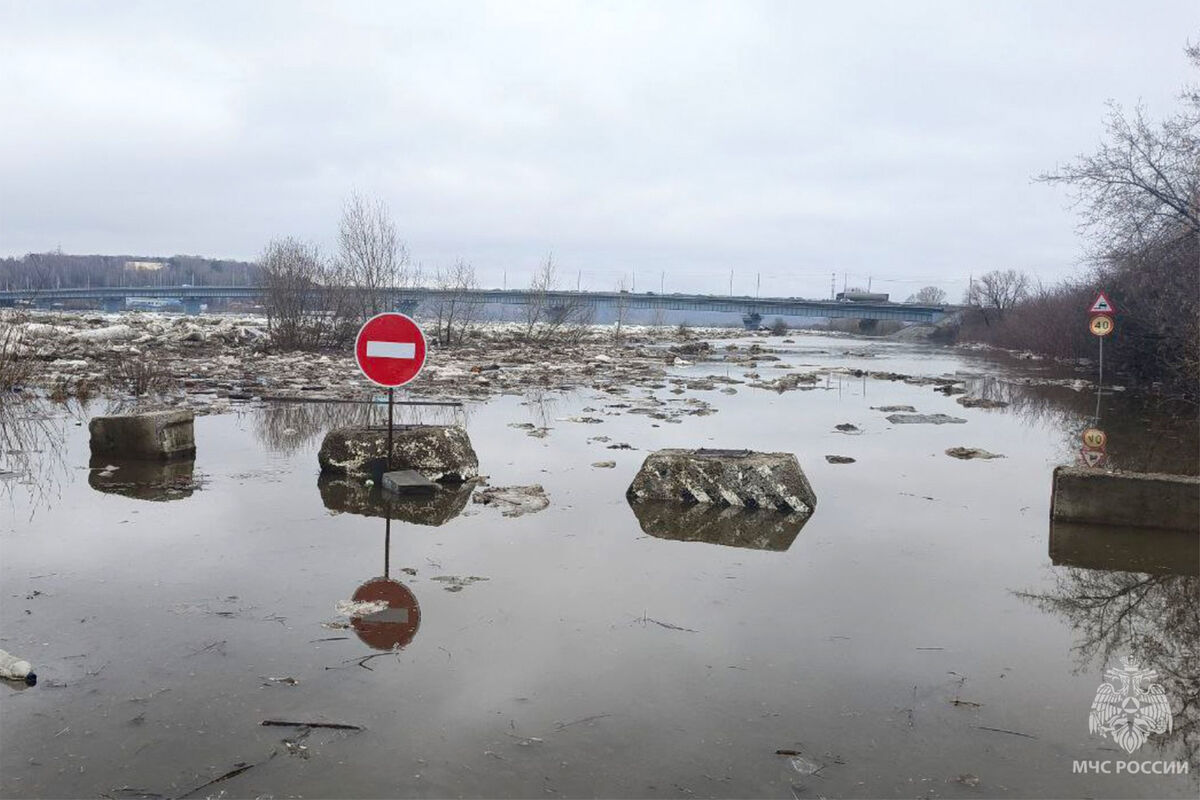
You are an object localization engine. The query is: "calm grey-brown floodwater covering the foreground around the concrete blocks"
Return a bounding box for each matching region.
[0,337,1200,798]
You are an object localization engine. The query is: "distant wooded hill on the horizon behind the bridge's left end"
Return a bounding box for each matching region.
[0,252,258,289]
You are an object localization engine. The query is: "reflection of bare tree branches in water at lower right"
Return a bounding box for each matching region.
[1018,561,1200,760]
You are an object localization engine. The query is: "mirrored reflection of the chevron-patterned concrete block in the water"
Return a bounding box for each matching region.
[629,498,809,551]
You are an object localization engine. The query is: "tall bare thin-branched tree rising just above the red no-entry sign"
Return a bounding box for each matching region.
[337,192,409,319]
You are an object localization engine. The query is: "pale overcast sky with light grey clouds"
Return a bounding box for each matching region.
[0,0,1200,297]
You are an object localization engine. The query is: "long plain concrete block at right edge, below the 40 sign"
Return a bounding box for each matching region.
[1050,467,1200,533]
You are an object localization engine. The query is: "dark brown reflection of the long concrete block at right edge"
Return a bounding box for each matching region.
[1050,522,1200,575]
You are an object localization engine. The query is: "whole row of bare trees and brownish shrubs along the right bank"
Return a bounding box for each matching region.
[960,46,1200,402]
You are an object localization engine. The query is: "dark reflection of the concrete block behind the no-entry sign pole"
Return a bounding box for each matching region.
[317,475,475,527]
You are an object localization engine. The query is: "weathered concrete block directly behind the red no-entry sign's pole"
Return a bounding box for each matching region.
[317,425,479,482]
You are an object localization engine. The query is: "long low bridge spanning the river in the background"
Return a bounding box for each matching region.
[0,287,954,327]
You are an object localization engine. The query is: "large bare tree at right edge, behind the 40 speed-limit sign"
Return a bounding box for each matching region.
[1040,46,1200,398]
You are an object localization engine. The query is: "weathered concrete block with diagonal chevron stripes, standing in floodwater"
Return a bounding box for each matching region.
[625,450,817,515]
